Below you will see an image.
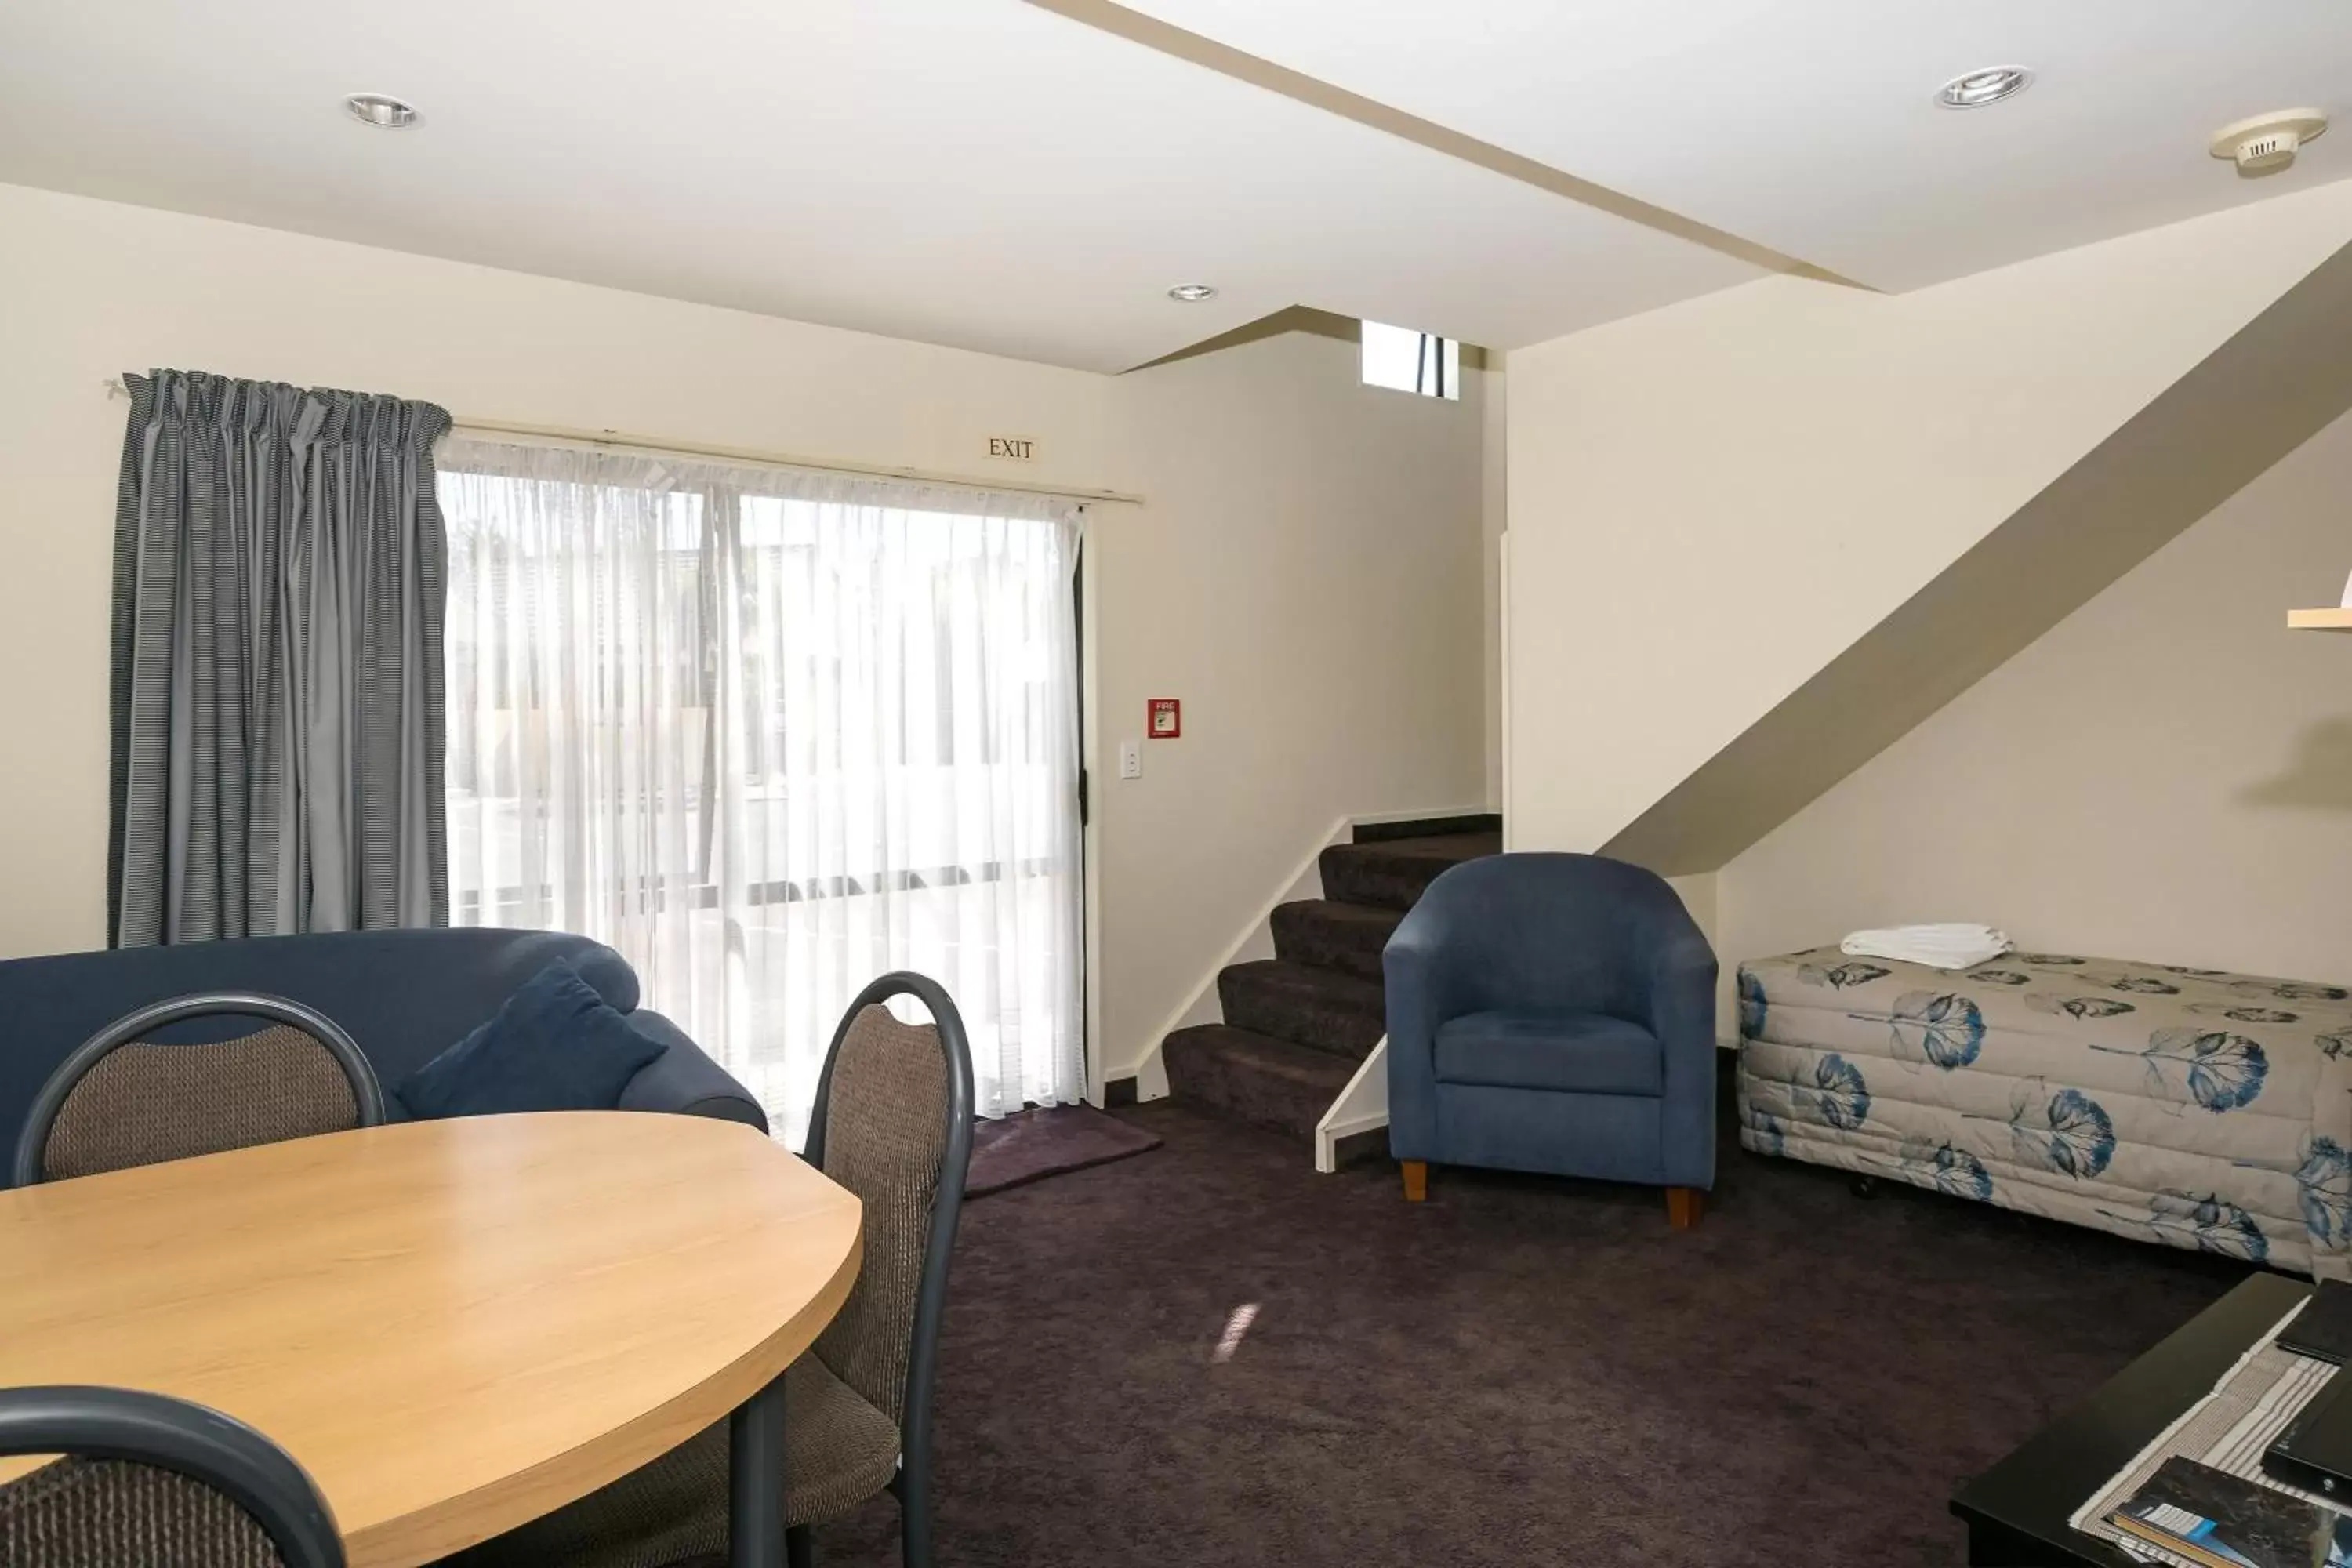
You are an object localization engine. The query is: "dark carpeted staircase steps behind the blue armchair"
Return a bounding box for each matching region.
[1160,815,1503,1138]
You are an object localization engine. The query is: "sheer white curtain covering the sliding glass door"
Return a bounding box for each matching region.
[440,437,1084,1145]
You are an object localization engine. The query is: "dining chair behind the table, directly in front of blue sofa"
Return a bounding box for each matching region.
[12,992,383,1187]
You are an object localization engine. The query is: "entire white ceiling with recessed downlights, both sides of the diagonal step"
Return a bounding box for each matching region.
[0,0,2352,369]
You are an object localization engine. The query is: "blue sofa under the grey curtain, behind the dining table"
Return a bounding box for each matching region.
[0,928,767,1189]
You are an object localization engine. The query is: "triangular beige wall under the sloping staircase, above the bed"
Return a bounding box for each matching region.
[1717,404,2352,980]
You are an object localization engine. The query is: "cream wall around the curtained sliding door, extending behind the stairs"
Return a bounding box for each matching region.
[0,186,1484,1074]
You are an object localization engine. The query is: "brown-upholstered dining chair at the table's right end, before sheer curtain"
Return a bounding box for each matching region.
[447,973,971,1568]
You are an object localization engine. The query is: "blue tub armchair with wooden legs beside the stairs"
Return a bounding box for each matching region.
[1385,853,1715,1229]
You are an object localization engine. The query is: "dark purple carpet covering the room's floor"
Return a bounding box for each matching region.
[816,1102,2246,1568]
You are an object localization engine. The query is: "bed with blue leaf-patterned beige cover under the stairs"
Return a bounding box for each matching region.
[1738,947,2352,1279]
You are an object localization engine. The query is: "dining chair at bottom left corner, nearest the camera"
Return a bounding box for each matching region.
[0,1387,343,1568]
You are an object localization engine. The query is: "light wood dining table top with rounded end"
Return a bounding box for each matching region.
[0,1112,858,1568]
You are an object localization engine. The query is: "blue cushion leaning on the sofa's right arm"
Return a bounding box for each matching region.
[395,959,663,1119]
